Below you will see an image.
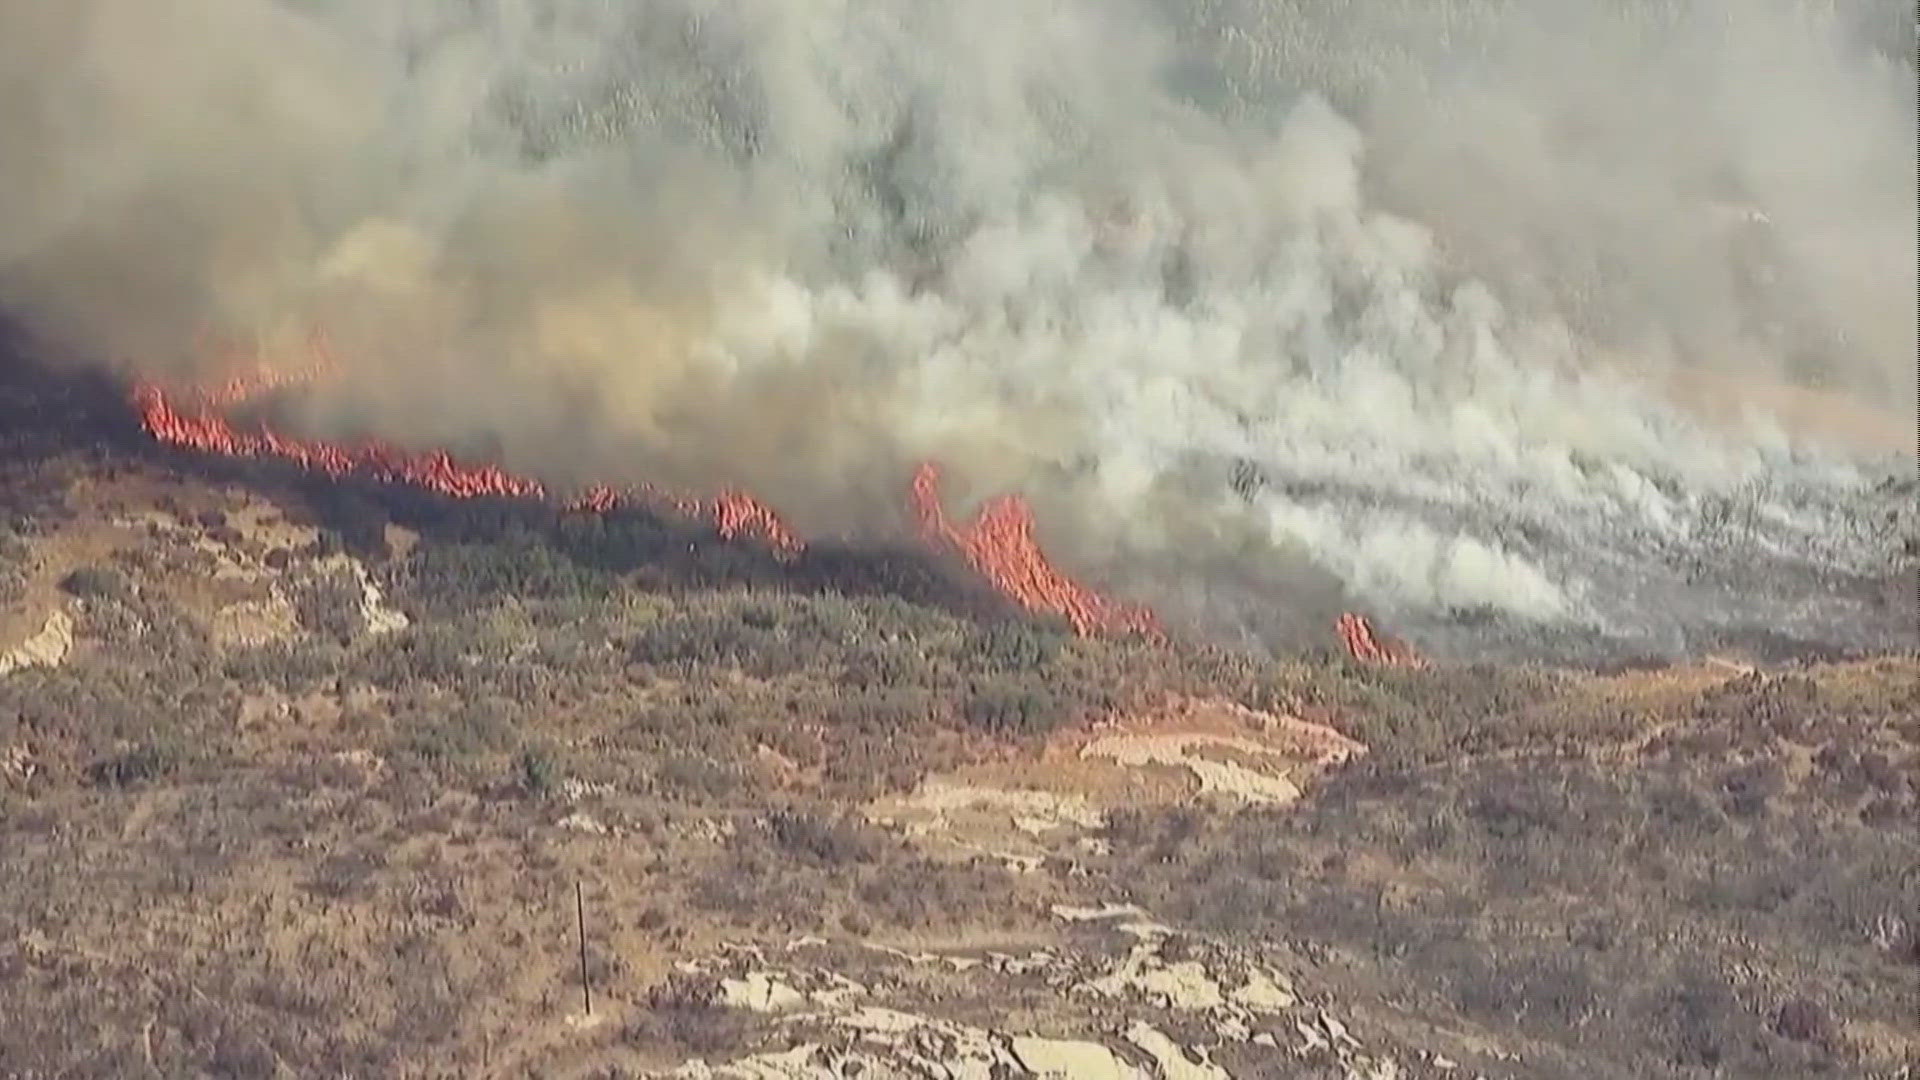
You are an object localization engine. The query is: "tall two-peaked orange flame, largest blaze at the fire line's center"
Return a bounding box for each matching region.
[914,461,1160,636]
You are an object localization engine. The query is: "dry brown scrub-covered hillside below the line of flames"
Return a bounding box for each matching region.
[0,357,1920,1080]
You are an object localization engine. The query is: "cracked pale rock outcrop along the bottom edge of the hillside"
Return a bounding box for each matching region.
[645,905,1398,1080]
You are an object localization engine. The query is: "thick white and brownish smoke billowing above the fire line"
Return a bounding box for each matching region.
[0,0,1916,655]
